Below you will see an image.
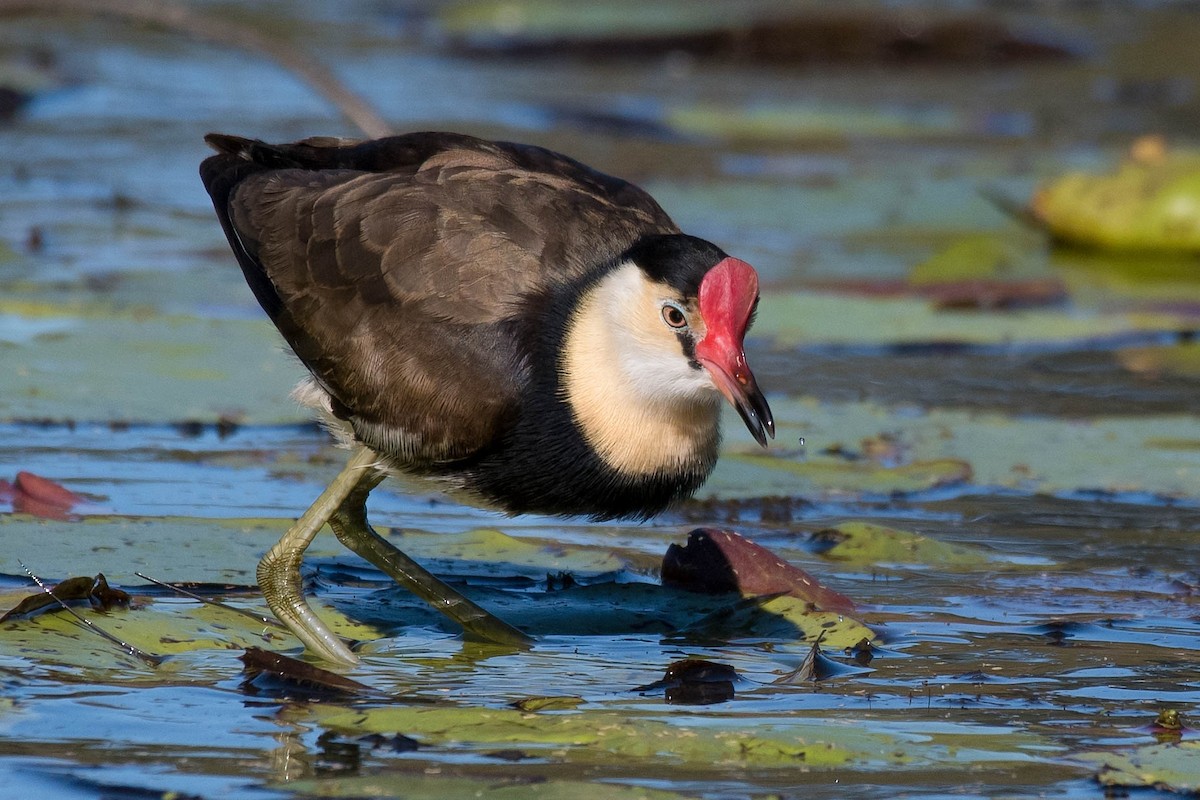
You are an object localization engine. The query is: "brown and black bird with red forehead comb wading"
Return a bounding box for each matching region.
[200,132,775,664]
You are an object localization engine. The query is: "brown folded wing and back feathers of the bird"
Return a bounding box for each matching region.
[202,134,678,465]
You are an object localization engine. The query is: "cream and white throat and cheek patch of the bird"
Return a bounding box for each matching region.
[560,264,720,476]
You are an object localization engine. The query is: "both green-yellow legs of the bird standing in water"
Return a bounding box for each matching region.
[258,447,532,664]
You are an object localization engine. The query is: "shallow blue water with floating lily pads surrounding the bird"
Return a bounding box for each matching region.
[0,2,1200,799]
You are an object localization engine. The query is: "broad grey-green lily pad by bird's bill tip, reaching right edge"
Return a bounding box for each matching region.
[701,397,1200,499]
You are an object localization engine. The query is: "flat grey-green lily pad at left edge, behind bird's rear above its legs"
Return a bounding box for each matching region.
[0,301,305,422]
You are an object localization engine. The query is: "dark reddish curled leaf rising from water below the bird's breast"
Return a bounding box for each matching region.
[662,528,854,614]
